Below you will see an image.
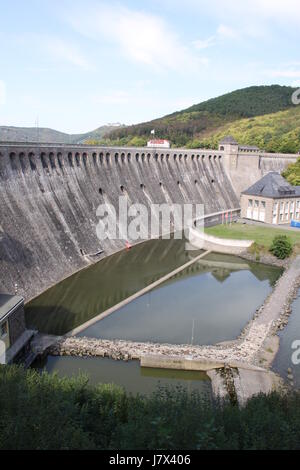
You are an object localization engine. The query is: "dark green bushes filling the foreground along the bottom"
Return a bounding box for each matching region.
[0,366,300,450]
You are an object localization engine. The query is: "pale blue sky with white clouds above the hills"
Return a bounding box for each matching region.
[0,0,300,133]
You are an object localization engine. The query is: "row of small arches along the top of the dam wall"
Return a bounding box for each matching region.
[0,143,227,176]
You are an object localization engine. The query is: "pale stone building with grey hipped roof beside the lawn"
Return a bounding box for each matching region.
[241,171,300,224]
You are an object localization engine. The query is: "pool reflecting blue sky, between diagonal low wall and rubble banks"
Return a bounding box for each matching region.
[80,255,279,345]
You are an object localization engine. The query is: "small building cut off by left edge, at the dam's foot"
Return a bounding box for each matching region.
[0,294,35,364]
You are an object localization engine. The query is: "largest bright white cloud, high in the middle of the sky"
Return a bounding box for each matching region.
[70,4,207,72]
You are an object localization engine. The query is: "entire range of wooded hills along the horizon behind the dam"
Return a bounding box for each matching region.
[0,85,300,153]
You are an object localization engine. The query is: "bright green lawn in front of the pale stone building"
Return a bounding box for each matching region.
[205,223,300,249]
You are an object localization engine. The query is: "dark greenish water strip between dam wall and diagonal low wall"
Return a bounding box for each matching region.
[25,239,199,335]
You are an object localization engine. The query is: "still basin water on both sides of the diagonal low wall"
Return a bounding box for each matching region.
[26,239,280,344]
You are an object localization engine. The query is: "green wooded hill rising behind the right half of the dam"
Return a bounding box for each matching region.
[101,85,299,151]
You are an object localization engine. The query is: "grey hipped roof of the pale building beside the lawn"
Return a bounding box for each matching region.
[242,171,300,199]
